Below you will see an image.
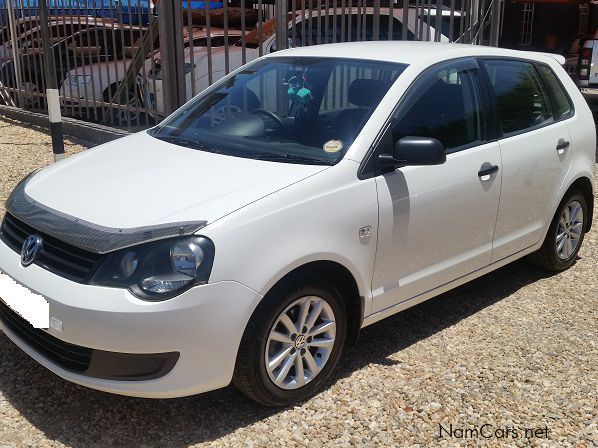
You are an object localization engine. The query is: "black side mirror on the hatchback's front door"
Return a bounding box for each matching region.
[378,136,446,169]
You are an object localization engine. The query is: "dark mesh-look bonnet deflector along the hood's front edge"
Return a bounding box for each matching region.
[6,173,207,254]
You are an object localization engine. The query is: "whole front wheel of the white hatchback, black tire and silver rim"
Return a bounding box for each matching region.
[233,278,347,407]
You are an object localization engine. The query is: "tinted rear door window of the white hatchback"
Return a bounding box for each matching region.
[484,59,554,134]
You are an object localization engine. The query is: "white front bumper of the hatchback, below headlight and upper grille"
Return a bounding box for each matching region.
[0,241,261,398]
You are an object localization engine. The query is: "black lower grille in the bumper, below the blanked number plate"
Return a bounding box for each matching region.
[0,300,93,373]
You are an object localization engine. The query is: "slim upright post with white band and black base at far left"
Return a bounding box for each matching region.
[39,0,64,162]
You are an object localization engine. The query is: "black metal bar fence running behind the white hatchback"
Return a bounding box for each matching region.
[0,0,502,129]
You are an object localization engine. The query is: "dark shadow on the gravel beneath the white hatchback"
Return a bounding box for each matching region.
[0,261,560,448]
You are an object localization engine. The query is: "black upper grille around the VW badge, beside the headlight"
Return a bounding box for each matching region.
[0,213,101,283]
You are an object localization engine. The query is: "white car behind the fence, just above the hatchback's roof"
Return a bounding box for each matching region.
[144,7,461,119]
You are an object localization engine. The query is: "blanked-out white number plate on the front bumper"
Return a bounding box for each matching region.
[0,272,50,329]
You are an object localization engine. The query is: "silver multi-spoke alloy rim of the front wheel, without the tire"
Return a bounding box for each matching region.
[265,296,336,390]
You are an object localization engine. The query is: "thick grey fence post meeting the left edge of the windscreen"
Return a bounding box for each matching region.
[158,0,187,115]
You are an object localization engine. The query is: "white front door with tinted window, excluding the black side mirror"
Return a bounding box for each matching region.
[372,59,502,312]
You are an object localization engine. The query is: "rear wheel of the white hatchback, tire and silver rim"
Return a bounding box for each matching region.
[529,190,589,272]
